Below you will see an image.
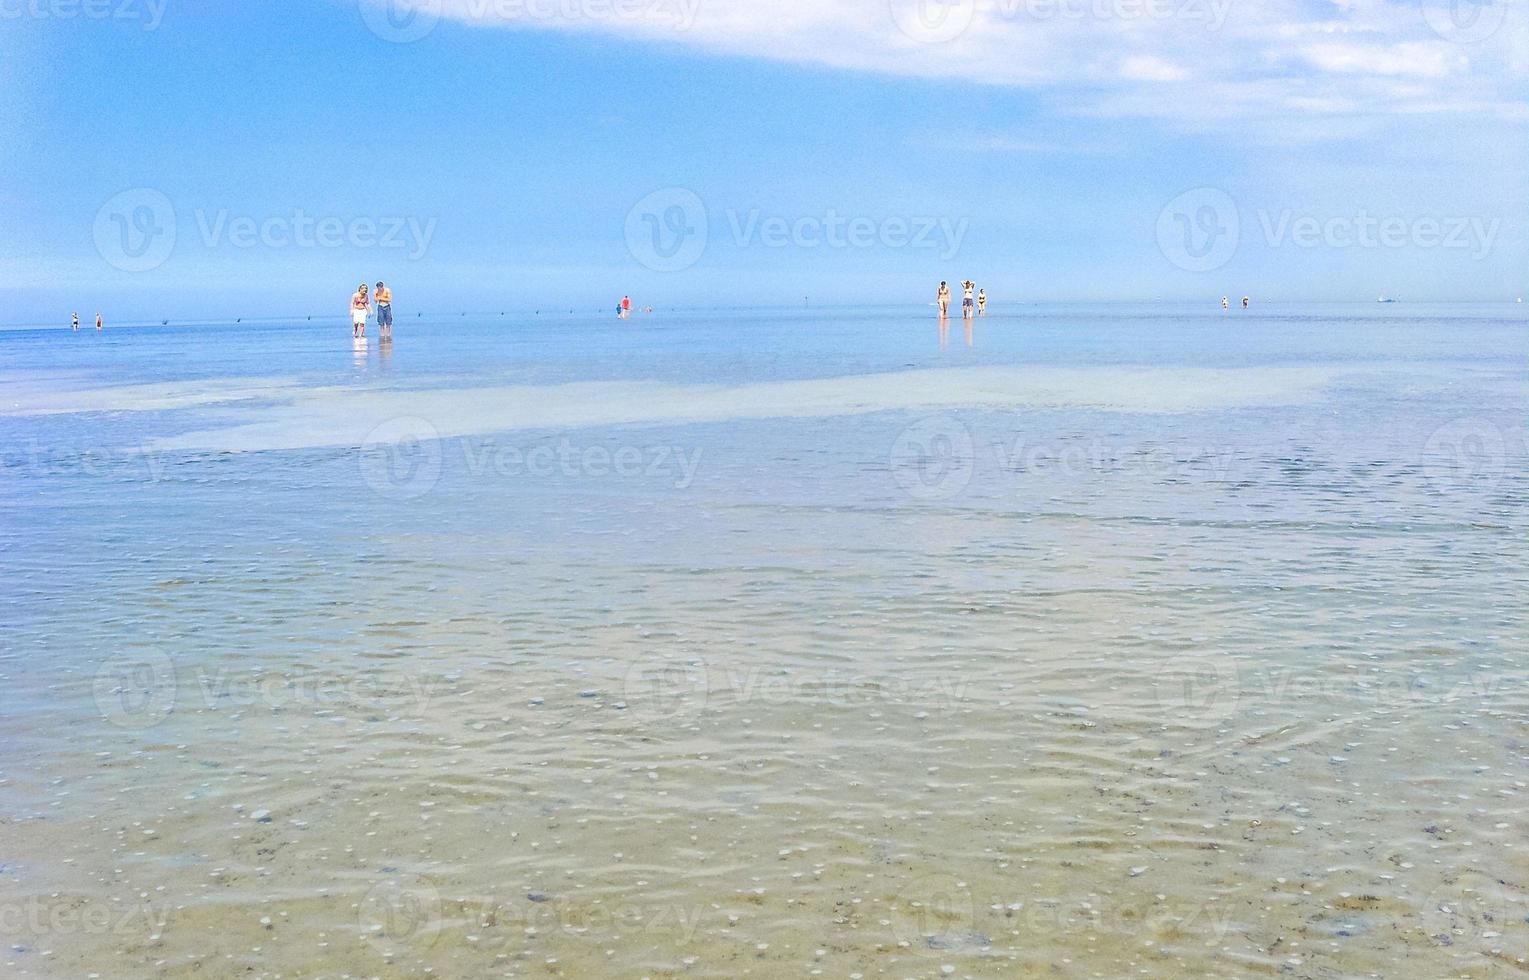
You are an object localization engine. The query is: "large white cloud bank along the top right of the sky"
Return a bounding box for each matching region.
[358,0,1529,130]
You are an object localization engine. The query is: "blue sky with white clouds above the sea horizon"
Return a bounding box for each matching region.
[0,0,1529,324]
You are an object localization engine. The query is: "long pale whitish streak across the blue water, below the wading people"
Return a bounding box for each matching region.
[6,364,1385,451]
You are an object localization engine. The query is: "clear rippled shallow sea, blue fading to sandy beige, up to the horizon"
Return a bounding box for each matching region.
[0,306,1529,978]
